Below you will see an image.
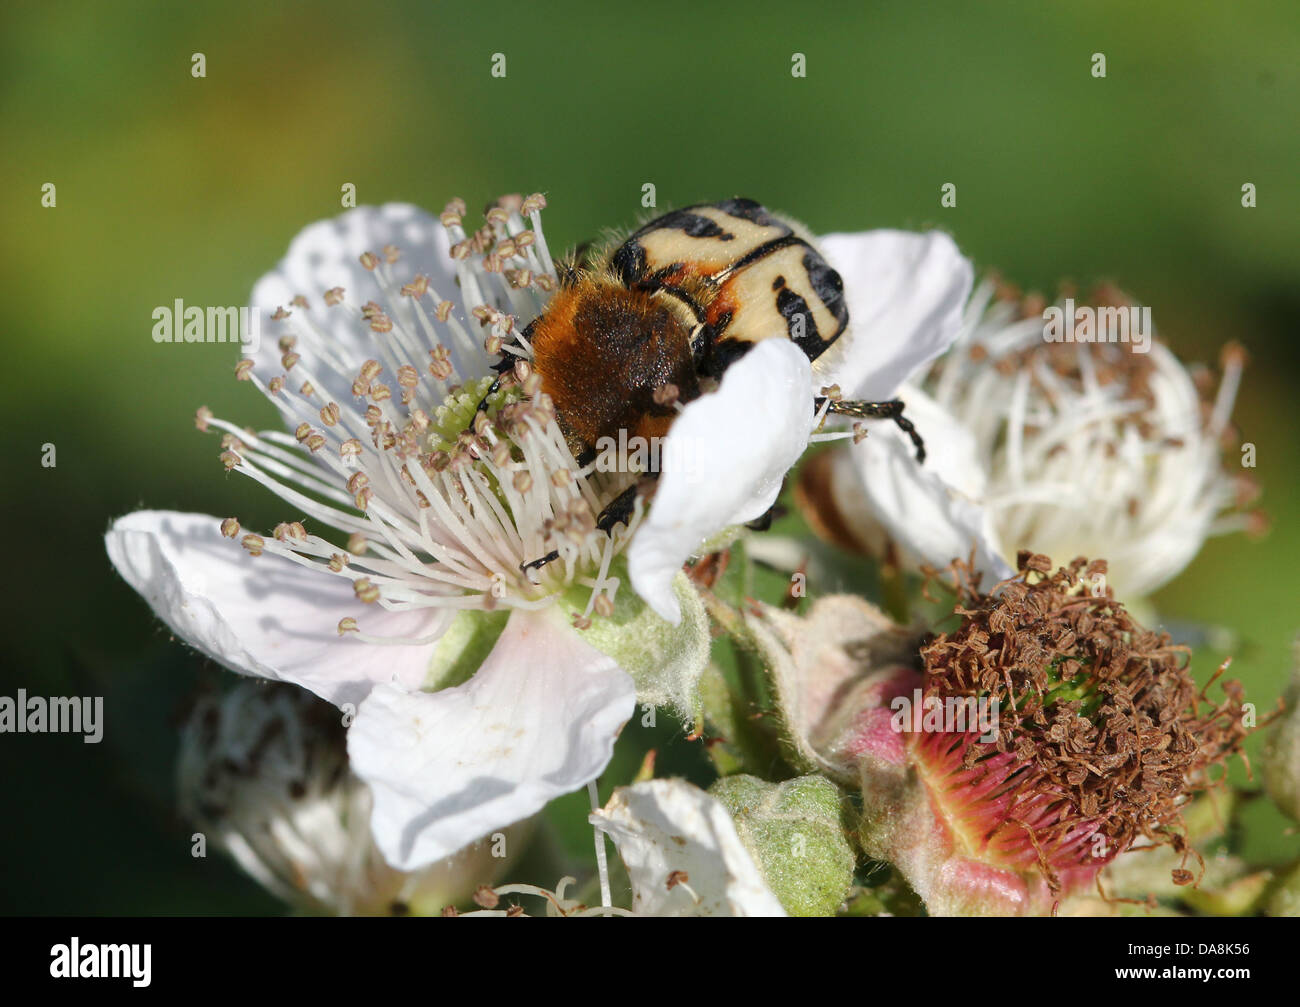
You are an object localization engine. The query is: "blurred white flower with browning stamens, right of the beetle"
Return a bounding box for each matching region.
[829,282,1260,598]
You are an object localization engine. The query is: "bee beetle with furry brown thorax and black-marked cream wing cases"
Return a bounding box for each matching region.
[478,199,926,568]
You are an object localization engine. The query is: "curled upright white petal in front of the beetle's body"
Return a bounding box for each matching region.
[628,339,814,625]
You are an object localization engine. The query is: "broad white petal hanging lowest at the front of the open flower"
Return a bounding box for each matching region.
[347,611,636,871]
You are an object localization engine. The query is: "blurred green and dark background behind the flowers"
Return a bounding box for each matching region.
[0,0,1300,913]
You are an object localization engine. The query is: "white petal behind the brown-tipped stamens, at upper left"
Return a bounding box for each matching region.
[245,203,465,404]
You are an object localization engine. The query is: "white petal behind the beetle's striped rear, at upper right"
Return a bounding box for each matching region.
[813,230,975,402]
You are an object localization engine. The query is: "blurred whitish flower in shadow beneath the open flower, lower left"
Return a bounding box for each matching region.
[178,681,528,916]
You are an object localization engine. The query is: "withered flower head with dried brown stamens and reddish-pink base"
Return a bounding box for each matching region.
[907,552,1249,895]
